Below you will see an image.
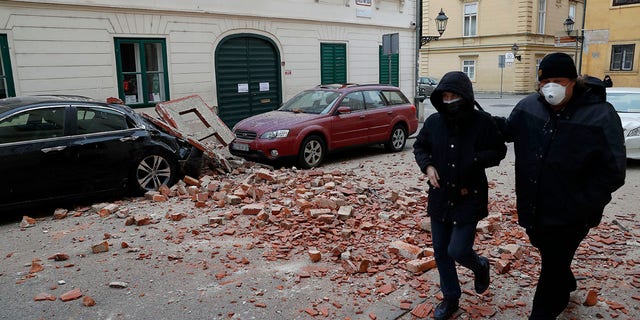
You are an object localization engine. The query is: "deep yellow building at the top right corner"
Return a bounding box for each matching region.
[582,0,640,87]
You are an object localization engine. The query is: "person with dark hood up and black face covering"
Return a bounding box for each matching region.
[413,71,507,319]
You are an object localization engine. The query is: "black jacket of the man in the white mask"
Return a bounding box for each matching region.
[498,83,626,228]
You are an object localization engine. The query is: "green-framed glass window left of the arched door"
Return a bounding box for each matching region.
[115,38,169,107]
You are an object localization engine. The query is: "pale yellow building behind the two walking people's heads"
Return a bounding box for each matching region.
[418,0,584,93]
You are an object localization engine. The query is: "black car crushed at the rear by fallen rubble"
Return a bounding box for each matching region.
[0,96,202,209]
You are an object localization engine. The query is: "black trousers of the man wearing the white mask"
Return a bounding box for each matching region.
[527,226,589,319]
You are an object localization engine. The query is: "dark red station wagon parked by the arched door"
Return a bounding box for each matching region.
[229,84,418,168]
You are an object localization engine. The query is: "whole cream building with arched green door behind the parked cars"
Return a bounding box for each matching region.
[0,0,417,126]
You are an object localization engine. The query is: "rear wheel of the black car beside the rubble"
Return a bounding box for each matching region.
[131,151,178,193]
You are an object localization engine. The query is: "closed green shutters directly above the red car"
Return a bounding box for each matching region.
[320,43,347,84]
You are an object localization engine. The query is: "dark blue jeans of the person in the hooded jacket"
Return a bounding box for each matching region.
[431,218,482,300]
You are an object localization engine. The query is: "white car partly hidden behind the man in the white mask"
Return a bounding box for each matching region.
[607,87,640,160]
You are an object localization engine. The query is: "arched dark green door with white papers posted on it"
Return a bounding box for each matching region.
[215,34,282,128]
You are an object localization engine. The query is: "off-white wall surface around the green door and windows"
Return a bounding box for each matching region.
[0,0,415,105]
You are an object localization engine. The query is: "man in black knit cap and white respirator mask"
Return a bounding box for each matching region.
[499,53,626,319]
